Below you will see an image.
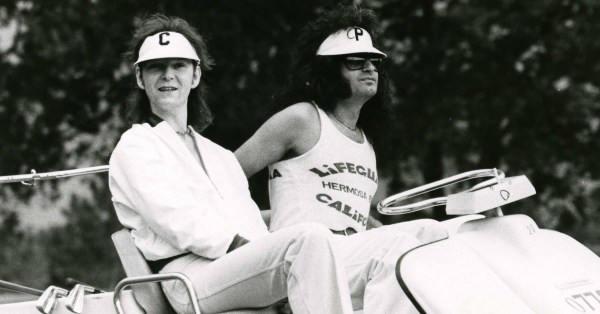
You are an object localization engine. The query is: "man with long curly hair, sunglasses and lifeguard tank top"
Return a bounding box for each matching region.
[235,5,447,313]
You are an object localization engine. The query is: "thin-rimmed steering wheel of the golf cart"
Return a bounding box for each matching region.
[377,168,505,215]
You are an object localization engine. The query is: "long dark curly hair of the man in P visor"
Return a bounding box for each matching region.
[274,4,391,151]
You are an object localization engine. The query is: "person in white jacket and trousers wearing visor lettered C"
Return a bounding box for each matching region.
[109,15,352,313]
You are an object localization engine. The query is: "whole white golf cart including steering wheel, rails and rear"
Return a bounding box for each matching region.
[0,168,600,314]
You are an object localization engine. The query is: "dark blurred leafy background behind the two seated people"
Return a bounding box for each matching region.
[0,0,600,289]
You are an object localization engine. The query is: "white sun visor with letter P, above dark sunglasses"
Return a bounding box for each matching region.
[317,26,387,58]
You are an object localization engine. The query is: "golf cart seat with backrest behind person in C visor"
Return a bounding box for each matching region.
[111,211,278,314]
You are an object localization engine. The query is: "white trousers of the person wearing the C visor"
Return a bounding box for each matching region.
[161,223,352,314]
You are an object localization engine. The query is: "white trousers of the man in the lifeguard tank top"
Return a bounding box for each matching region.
[336,219,448,314]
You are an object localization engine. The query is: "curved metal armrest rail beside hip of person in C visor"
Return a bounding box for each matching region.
[113,273,200,314]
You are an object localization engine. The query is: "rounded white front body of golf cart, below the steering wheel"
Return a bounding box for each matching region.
[397,215,600,314]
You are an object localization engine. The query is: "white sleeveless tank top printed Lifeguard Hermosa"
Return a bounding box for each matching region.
[269,105,378,231]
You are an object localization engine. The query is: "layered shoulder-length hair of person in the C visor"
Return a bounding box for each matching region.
[125,14,214,132]
